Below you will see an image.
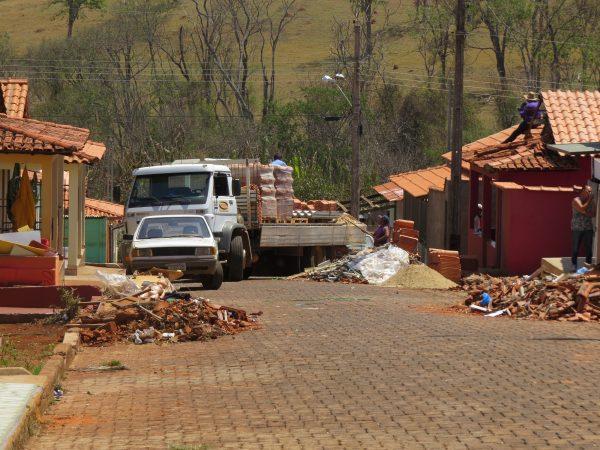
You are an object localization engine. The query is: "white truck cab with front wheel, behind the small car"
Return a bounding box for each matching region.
[123,163,252,281]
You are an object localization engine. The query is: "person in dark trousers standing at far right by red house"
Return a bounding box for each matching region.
[571,186,596,271]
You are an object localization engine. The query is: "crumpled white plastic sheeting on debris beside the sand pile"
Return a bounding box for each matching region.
[352,245,410,284]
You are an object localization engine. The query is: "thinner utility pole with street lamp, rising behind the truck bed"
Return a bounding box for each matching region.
[350,20,361,218]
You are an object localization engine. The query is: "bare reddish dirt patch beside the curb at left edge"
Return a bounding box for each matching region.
[0,323,64,375]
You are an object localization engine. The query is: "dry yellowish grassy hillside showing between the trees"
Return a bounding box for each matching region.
[0,0,502,132]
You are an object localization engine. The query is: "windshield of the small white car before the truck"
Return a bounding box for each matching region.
[137,216,210,239]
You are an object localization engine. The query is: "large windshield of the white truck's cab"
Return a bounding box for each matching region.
[128,172,210,208]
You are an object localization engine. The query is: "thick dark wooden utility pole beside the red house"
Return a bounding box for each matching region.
[450,0,464,250]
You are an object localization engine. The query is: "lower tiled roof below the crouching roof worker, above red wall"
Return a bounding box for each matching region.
[463,138,579,171]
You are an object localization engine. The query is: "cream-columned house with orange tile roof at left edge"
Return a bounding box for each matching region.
[0,79,106,273]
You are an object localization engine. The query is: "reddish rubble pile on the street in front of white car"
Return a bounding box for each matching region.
[68,270,261,345]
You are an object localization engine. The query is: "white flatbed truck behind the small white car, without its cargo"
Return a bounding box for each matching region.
[122,161,364,281]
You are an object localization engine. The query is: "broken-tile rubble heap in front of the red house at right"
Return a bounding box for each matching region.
[462,271,600,322]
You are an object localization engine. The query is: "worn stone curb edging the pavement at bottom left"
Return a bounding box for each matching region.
[0,328,80,450]
